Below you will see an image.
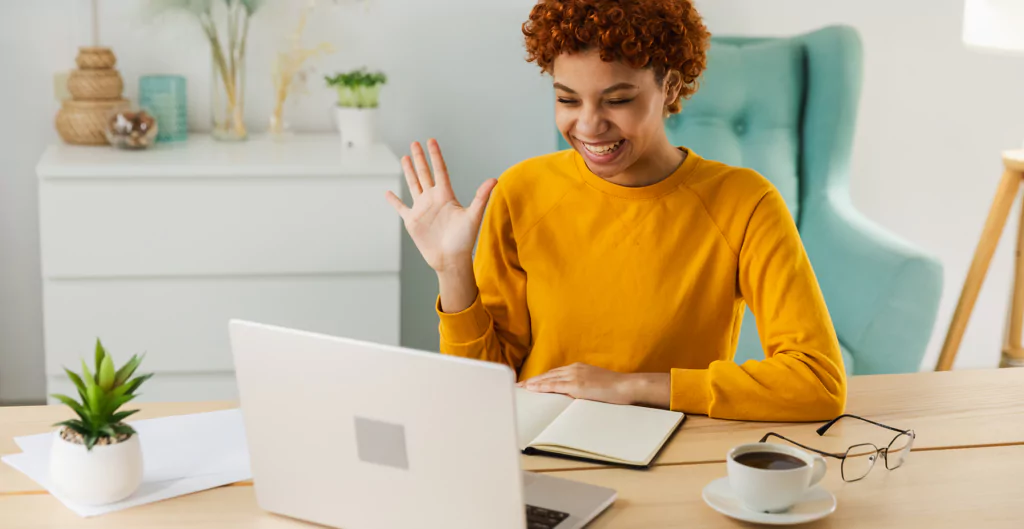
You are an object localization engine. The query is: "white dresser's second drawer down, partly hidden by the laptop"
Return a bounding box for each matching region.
[43,273,399,372]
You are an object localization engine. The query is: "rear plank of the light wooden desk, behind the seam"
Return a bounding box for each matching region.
[0,369,1024,487]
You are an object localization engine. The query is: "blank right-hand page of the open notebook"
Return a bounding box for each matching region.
[532,400,682,465]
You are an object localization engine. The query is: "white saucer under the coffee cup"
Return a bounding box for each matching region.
[701,477,836,525]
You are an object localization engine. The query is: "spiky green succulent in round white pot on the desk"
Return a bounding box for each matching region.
[50,339,153,505]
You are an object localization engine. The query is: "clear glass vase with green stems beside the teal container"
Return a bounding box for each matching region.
[210,41,249,141]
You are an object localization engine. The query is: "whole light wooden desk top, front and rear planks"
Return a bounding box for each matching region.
[6,369,1024,529]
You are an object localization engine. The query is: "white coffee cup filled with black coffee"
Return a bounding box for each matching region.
[726,443,827,513]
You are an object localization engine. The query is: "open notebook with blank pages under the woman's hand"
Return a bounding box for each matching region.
[515,388,685,467]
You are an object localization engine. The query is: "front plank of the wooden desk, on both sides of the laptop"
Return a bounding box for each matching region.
[0,446,1024,529]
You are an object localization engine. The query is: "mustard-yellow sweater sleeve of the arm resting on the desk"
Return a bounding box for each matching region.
[671,188,846,421]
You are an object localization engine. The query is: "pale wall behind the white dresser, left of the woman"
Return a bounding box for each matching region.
[0,0,554,403]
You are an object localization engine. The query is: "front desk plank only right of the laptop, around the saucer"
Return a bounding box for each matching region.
[577,446,1024,529]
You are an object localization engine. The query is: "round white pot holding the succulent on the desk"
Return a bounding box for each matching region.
[50,432,142,505]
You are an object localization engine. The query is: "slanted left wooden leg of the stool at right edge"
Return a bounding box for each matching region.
[935,170,1024,371]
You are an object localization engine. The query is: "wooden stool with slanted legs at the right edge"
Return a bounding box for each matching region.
[935,150,1024,371]
